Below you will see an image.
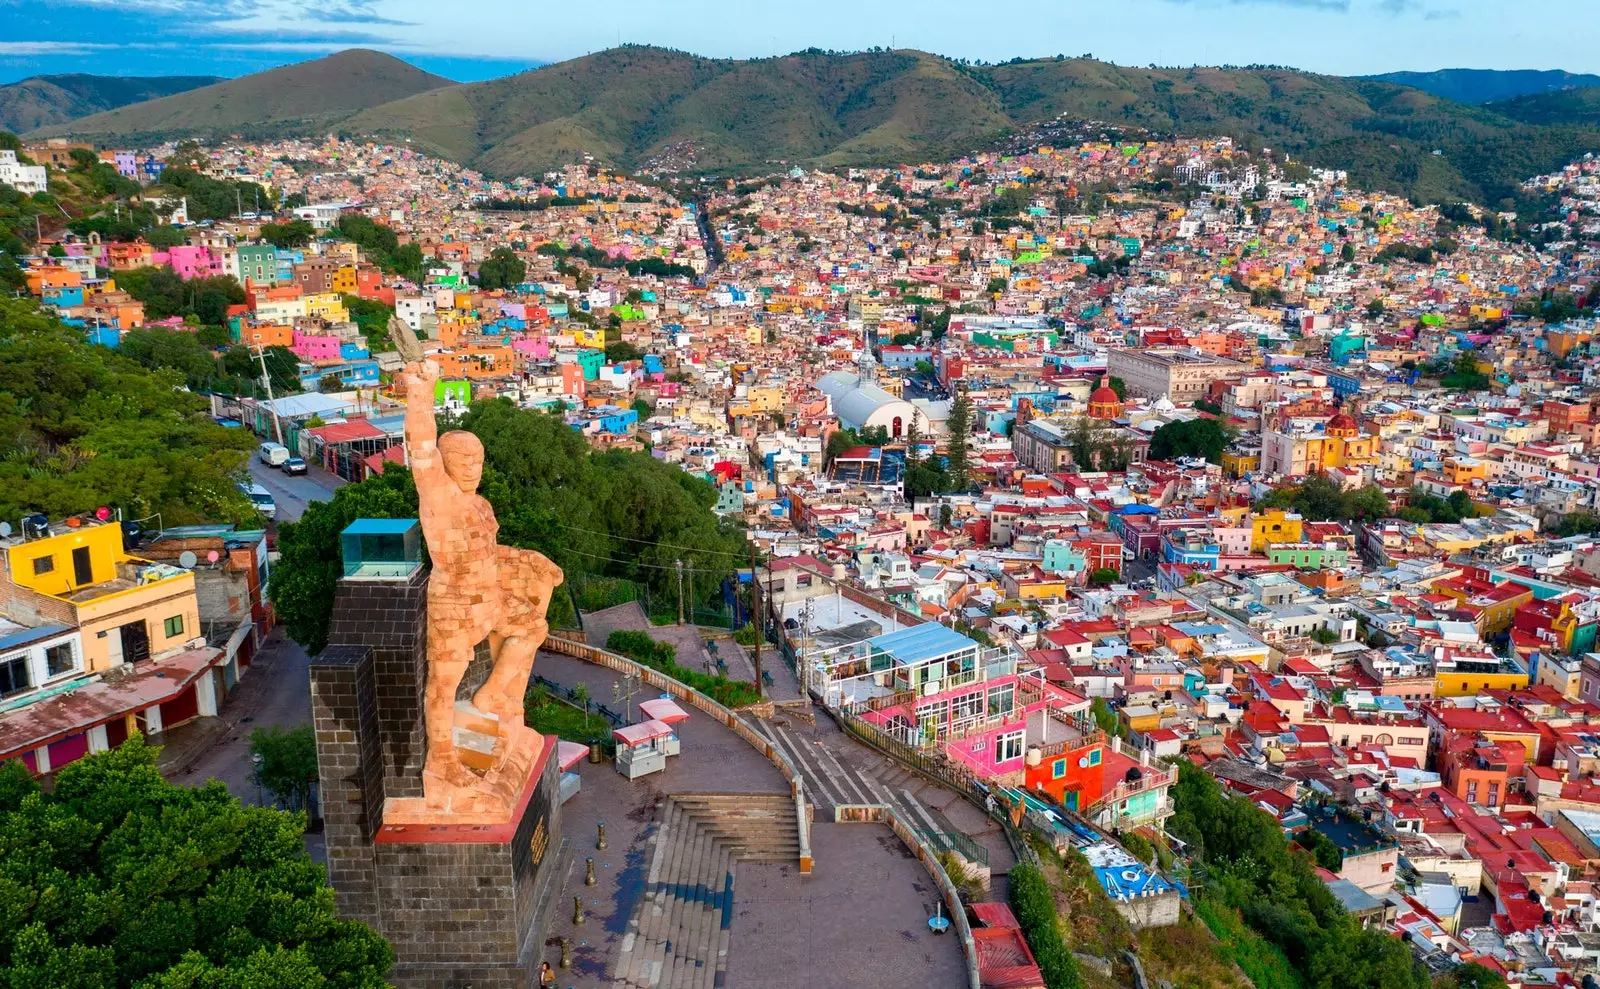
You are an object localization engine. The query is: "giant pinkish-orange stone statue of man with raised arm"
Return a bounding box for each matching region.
[384,342,562,824]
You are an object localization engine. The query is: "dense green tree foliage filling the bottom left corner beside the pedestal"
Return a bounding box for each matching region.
[0,736,394,989]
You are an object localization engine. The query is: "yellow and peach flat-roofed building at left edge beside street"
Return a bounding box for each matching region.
[0,522,202,674]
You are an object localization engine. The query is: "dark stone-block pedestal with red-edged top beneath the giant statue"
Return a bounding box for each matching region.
[310,575,562,989]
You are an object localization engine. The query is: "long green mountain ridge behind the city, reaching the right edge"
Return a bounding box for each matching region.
[342,48,1600,202]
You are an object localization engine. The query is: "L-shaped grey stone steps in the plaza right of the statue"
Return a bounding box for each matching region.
[611,794,800,989]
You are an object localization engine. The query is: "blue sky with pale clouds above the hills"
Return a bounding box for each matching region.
[0,0,1600,82]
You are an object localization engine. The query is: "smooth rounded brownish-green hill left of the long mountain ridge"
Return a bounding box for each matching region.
[32,48,454,141]
